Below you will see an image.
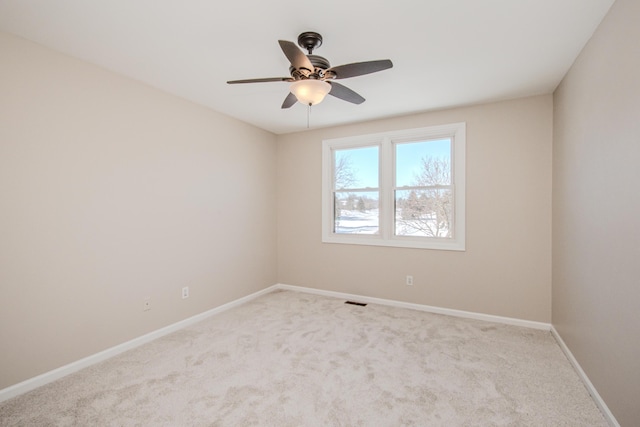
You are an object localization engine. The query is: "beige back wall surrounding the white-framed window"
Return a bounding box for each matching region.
[278,95,553,322]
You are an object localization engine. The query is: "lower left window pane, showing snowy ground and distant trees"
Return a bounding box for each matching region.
[333,191,379,234]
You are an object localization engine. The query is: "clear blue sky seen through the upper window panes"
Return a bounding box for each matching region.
[335,139,451,188]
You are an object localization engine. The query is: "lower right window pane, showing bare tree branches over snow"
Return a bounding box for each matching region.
[395,188,453,238]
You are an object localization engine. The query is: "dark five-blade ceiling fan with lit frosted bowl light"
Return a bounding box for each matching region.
[227,31,393,108]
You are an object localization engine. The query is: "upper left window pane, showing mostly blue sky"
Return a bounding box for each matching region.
[333,146,379,190]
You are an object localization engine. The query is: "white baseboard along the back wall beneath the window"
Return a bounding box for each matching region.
[274,284,551,331]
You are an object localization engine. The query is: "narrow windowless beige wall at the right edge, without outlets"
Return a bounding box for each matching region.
[553,0,640,426]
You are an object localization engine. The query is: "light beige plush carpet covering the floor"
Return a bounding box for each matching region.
[0,291,607,427]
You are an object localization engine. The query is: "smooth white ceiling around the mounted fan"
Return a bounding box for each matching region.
[0,0,613,134]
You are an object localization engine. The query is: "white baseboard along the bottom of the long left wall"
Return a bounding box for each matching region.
[0,285,277,402]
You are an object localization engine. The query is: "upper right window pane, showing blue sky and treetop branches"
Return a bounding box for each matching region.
[396,138,451,187]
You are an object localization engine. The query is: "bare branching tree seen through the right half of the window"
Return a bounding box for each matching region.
[396,156,453,238]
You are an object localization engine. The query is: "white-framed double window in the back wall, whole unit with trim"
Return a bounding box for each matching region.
[322,123,465,250]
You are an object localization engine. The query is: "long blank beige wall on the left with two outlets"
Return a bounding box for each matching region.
[0,33,276,389]
